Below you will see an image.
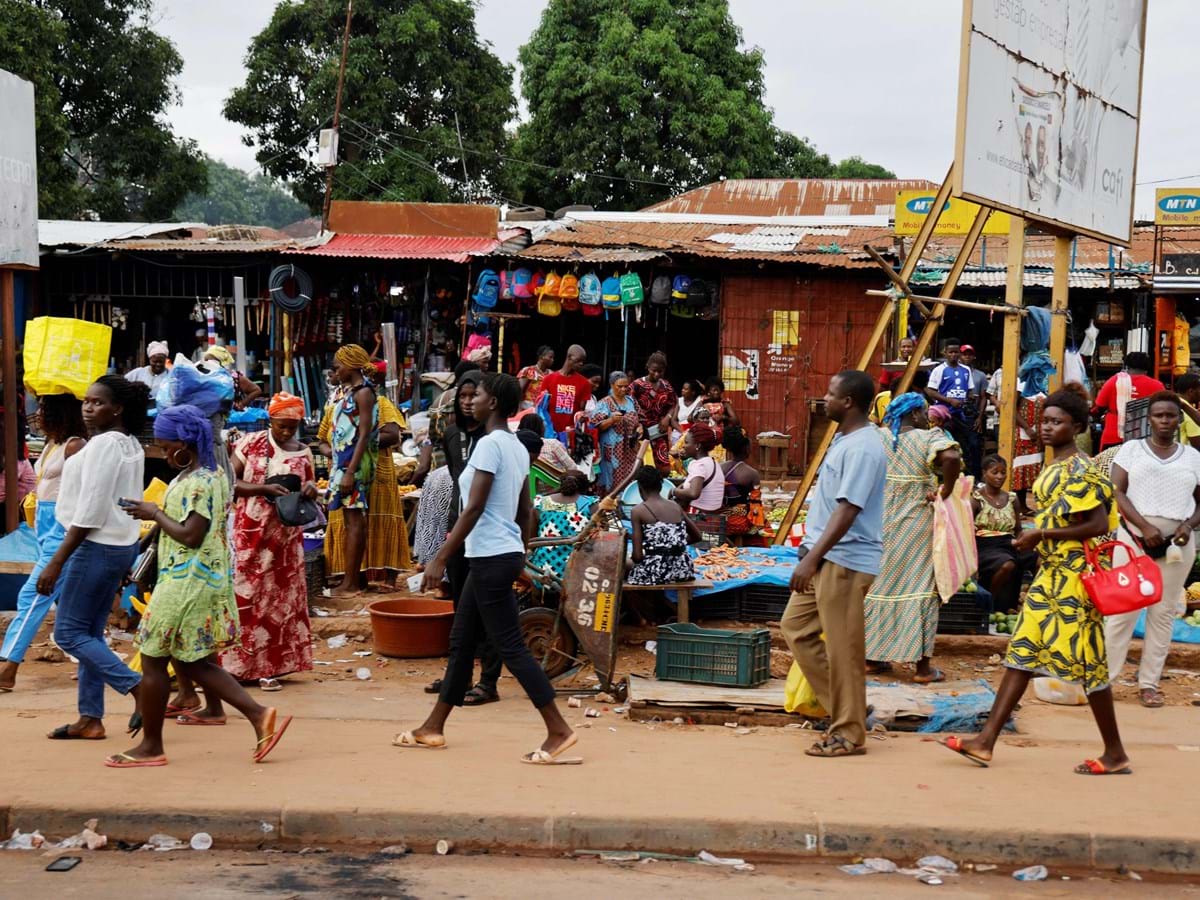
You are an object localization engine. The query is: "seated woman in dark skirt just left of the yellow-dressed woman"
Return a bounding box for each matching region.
[971,454,1021,610]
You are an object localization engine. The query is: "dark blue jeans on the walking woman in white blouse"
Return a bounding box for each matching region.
[54,541,142,719]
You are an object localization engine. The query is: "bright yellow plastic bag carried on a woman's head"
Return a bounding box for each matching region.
[24,316,113,400]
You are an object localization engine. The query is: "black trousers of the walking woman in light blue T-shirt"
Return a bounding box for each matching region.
[438,553,554,709]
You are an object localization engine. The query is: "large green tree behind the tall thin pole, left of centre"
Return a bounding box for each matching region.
[224,0,516,211]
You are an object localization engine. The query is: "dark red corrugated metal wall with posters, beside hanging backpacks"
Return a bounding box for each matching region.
[721,269,883,473]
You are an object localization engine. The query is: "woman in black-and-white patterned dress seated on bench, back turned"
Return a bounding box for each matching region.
[625,468,700,584]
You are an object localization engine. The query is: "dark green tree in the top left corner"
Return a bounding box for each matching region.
[0,0,204,220]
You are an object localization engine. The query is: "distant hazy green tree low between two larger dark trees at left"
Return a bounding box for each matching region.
[173,157,308,228]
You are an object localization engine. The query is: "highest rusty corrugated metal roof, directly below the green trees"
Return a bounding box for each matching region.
[644,178,938,216]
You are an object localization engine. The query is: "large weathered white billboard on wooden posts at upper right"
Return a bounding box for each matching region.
[954,0,1146,245]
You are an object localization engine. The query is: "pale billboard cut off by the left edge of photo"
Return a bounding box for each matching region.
[0,68,37,269]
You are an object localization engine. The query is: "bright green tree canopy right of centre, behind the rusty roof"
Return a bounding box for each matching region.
[506,0,890,209]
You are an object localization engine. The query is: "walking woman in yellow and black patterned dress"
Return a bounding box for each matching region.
[943,391,1133,775]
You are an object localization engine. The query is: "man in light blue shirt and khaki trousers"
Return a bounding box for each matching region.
[780,370,888,757]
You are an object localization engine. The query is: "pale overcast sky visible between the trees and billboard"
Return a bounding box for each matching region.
[156,0,1200,218]
